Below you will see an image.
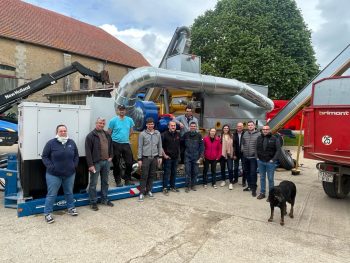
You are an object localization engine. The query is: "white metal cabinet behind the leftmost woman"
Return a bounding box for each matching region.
[18,102,91,160]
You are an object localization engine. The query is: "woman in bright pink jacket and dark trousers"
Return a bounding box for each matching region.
[203,128,221,189]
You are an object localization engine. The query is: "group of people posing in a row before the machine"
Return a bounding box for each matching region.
[42,105,281,223]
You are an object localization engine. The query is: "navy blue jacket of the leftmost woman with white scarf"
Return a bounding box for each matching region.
[42,138,79,176]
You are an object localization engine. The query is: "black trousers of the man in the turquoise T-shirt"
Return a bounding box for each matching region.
[113,142,133,185]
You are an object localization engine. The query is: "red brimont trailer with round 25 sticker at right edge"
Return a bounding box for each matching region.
[304,76,350,198]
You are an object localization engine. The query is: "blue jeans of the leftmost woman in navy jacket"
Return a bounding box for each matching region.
[44,173,75,215]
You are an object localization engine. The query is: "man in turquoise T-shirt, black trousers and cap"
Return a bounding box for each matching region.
[108,105,135,187]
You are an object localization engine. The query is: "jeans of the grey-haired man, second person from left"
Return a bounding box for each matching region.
[89,160,111,204]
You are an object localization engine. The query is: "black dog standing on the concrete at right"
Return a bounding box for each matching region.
[268,181,297,226]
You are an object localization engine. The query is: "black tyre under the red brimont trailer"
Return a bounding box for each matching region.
[322,175,350,199]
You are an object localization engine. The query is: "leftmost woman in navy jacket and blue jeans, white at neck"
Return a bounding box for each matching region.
[42,124,79,224]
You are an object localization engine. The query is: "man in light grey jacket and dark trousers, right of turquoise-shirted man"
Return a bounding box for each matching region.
[137,118,163,202]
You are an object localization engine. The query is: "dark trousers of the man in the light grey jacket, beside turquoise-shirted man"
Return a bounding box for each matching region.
[140,158,158,194]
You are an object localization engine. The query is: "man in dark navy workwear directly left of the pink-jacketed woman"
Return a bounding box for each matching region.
[182,122,204,193]
